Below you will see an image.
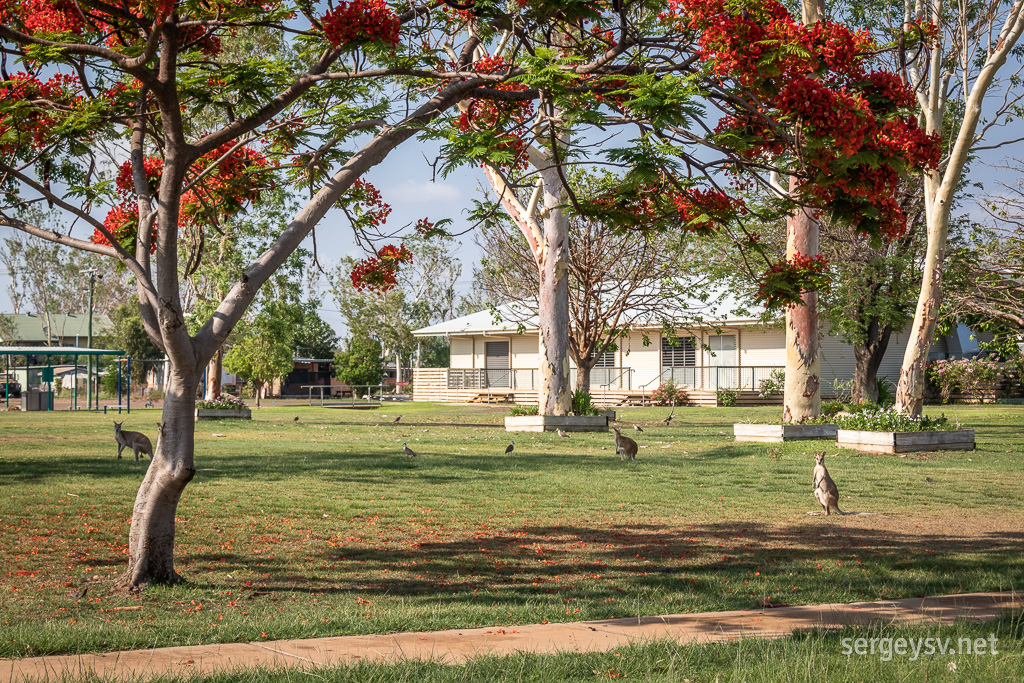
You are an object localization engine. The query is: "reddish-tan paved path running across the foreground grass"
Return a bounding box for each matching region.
[0,593,1024,683]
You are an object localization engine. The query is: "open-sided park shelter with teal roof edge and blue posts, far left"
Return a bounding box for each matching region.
[0,346,131,413]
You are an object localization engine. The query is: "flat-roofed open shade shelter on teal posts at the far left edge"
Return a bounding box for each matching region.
[0,346,131,413]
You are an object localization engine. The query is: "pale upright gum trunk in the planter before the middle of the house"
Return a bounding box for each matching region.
[537,171,572,415]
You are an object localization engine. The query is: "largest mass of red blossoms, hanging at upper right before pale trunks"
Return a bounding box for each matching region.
[665,0,939,239]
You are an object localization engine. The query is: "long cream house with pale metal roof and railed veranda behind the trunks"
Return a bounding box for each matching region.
[413,301,948,405]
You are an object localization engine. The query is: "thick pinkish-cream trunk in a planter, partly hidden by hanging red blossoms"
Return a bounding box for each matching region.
[782,178,821,423]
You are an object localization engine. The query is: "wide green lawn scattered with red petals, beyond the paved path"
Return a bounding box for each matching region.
[0,403,1024,659]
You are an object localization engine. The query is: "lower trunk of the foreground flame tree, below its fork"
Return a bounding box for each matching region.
[116,369,201,591]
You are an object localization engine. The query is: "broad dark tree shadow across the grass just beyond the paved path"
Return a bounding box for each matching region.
[182,520,1024,614]
